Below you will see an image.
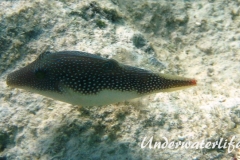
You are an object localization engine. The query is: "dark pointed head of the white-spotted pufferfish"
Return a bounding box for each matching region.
[6,52,59,91]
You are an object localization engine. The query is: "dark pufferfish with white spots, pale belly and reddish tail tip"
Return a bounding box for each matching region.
[7,51,196,106]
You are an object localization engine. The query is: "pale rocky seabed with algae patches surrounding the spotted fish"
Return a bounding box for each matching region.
[0,0,240,160]
